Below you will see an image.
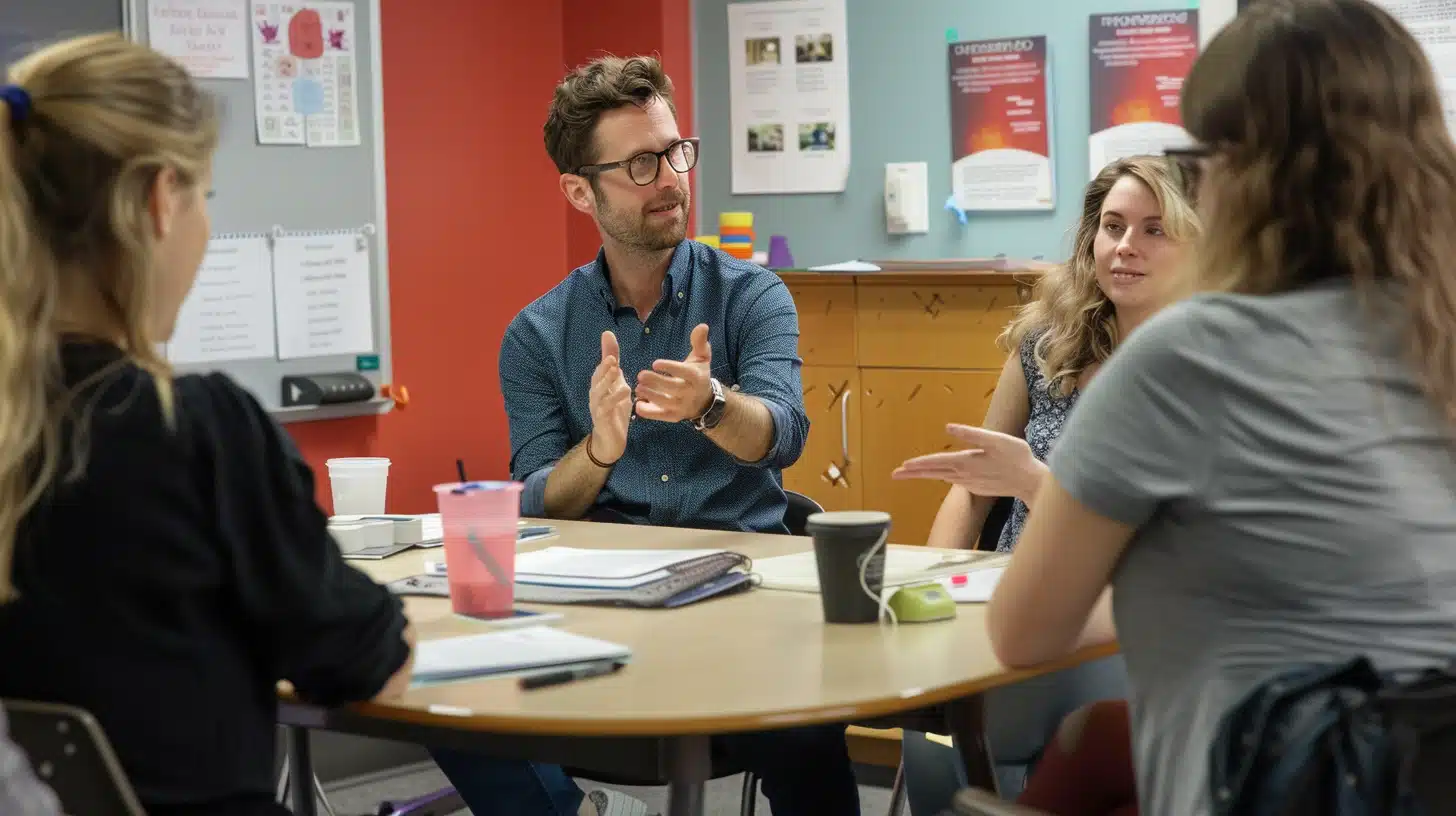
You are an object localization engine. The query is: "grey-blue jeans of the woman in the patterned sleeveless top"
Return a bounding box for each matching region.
[900,656,1127,816]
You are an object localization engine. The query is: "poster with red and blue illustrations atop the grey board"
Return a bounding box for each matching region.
[252,0,360,147]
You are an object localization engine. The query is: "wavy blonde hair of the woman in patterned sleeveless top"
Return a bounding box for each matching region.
[1000,156,1198,396]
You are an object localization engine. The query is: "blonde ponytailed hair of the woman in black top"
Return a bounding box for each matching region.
[0,35,217,602]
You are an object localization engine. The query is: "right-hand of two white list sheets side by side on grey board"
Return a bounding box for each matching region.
[274,233,374,360]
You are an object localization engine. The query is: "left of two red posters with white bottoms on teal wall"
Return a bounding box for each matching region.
[949,36,1056,211]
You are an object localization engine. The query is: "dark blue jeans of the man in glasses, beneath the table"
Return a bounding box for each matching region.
[430,726,859,816]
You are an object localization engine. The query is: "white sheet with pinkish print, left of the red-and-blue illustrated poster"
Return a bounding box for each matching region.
[147,0,248,79]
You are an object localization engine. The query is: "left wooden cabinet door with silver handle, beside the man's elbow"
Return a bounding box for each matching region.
[783,366,863,510]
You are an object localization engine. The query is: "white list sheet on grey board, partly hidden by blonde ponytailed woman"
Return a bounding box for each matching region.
[166,236,277,363]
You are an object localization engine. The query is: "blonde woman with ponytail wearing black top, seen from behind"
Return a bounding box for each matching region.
[0,35,412,816]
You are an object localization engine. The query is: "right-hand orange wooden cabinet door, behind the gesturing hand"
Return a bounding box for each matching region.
[859,369,1000,544]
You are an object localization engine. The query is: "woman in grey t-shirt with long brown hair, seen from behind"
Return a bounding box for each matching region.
[989,0,1456,816]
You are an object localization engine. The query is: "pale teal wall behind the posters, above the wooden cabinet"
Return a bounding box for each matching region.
[693,0,1203,267]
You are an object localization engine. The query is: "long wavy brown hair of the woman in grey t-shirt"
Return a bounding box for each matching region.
[1182,0,1456,424]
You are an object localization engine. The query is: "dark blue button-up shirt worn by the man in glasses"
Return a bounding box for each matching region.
[501,240,810,532]
